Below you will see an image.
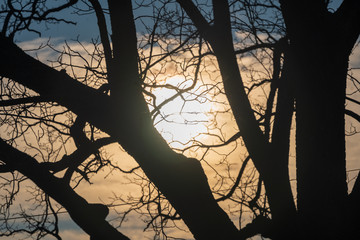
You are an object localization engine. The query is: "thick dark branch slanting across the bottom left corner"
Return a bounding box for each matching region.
[0,140,129,240]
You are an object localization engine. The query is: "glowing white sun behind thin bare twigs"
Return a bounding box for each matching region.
[152,75,211,147]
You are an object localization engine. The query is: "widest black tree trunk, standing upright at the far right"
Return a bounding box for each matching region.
[280,0,360,239]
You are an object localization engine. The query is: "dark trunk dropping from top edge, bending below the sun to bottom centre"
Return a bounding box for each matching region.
[108,0,238,239]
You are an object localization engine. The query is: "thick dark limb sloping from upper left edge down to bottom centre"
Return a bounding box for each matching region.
[0,36,242,239]
